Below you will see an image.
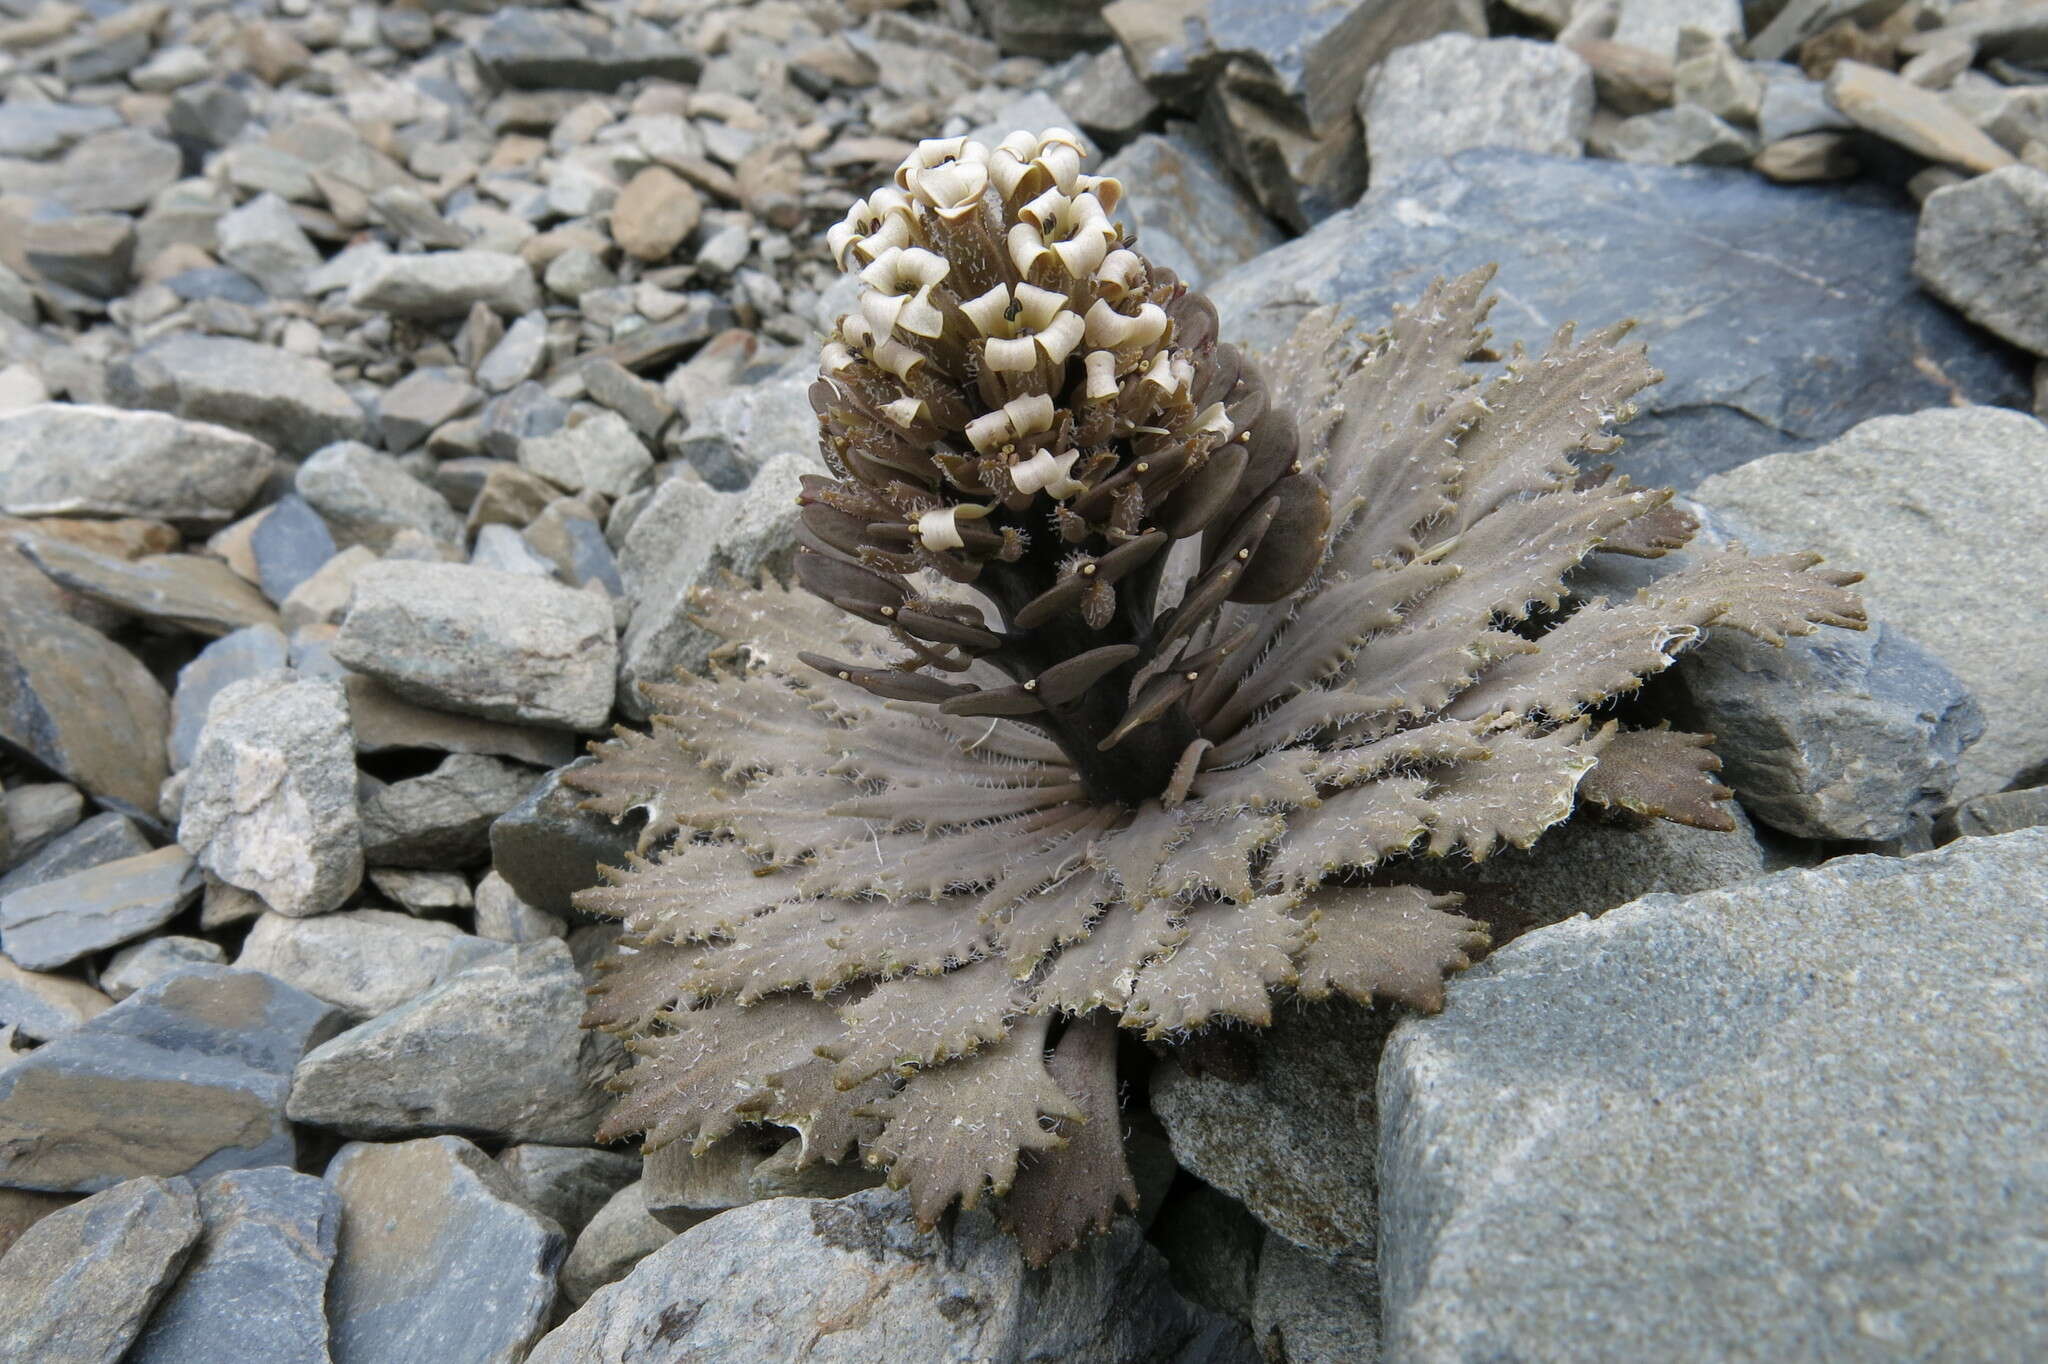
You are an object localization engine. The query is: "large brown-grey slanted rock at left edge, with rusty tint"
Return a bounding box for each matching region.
[0,577,170,813]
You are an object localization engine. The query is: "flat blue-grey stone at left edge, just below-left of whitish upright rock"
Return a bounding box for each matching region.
[0,848,199,971]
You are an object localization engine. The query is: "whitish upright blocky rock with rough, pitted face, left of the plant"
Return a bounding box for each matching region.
[178,670,362,918]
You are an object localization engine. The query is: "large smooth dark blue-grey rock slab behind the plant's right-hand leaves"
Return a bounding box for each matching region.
[1212,150,2030,489]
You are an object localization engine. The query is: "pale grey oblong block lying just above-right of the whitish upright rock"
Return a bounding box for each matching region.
[334,563,618,733]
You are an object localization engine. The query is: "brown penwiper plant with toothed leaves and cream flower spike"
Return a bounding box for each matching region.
[569,131,1862,1262]
